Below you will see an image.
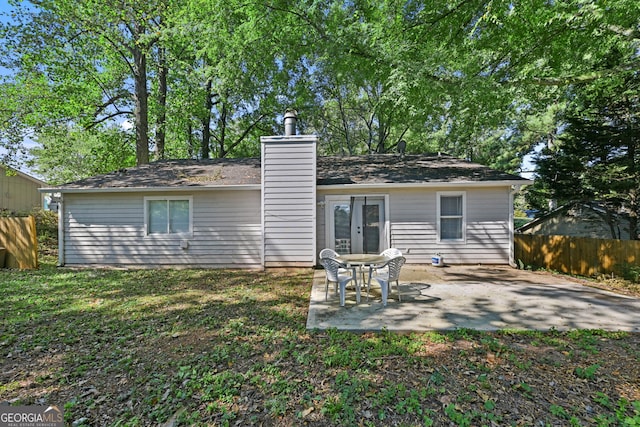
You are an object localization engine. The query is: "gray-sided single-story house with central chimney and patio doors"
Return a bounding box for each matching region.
[38,133,530,268]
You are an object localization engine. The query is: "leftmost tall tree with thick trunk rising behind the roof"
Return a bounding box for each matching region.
[0,0,171,164]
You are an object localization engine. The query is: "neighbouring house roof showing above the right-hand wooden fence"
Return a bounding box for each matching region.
[517,202,631,240]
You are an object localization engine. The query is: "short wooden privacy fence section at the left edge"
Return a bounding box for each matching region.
[0,216,38,269]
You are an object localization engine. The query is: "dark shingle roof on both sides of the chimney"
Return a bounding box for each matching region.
[48,154,528,190]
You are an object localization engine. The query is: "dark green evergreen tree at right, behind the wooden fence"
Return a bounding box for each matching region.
[534,74,640,239]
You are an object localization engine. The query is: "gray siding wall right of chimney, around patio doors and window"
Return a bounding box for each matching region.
[316,186,511,264]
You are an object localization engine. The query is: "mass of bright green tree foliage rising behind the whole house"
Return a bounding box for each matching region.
[0,0,640,181]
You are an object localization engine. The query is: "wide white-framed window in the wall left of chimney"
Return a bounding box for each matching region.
[145,197,192,235]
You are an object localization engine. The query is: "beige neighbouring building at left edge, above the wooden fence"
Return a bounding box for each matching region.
[0,165,48,212]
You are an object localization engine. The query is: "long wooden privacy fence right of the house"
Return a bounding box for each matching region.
[514,234,640,276]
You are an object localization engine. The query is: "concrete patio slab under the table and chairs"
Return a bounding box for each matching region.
[307,265,640,332]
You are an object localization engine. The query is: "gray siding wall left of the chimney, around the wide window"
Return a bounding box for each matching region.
[63,190,262,268]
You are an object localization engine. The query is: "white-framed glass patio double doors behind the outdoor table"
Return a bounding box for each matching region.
[327,196,387,254]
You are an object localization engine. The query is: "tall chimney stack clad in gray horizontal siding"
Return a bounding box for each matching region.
[261,135,316,267]
